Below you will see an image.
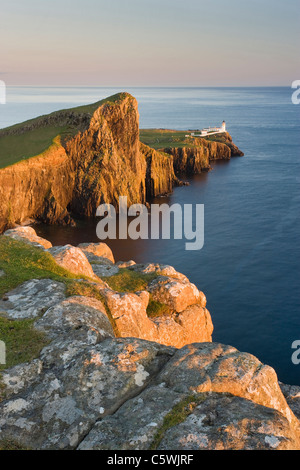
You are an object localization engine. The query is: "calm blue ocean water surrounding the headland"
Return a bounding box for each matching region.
[0,88,300,385]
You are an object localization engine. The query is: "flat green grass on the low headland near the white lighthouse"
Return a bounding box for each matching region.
[140,129,226,150]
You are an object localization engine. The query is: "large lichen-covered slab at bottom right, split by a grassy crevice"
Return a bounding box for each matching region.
[79,344,300,450]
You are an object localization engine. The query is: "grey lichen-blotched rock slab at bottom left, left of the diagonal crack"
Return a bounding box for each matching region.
[0,338,170,449]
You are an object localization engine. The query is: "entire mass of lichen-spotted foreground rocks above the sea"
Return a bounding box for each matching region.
[0,227,300,450]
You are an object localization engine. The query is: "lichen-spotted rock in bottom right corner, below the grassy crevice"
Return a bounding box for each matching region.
[158,393,300,450]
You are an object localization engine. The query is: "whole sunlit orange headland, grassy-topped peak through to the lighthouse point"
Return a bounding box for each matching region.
[0,93,240,231]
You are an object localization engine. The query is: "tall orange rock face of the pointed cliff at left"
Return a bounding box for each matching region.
[0,93,176,230]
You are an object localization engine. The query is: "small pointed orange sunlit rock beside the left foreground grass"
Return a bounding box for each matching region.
[48,245,95,278]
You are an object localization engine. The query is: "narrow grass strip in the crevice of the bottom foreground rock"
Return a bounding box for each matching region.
[150,393,207,450]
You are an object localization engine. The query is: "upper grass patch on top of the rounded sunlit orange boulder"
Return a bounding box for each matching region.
[101,268,158,292]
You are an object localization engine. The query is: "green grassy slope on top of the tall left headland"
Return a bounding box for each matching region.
[0,93,125,168]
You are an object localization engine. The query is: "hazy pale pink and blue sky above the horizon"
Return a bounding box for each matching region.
[0,0,300,86]
